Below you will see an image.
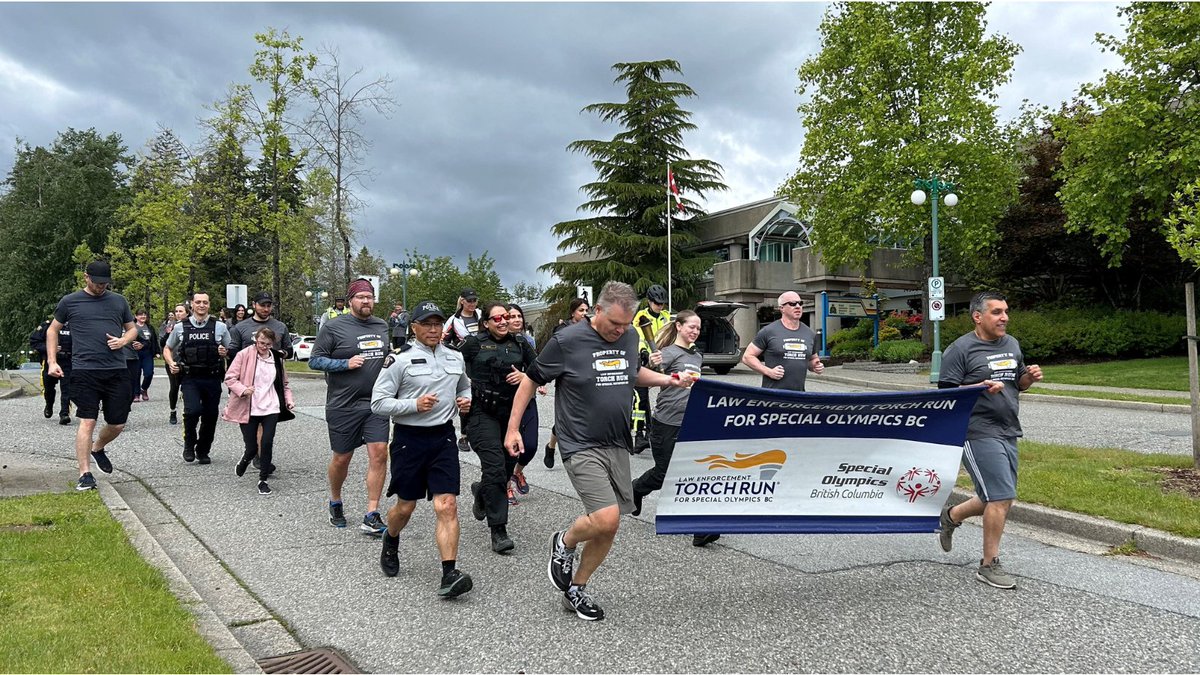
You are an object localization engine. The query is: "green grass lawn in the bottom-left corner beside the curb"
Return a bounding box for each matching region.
[0,491,230,673]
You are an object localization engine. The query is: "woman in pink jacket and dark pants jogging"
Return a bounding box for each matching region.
[222,328,296,495]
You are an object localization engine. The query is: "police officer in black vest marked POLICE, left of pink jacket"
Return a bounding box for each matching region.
[162,293,229,464]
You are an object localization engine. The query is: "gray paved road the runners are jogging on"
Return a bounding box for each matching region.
[0,376,1200,673]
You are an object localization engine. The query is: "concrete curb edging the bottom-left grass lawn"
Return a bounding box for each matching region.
[97,482,263,673]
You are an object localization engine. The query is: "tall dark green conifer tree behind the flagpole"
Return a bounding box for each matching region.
[541,59,727,305]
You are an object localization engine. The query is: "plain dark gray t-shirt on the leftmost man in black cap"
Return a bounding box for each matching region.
[54,284,133,370]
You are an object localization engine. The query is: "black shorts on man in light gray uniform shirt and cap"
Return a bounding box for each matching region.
[388,422,460,502]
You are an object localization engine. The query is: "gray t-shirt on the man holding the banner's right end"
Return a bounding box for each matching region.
[937,333,1025,441]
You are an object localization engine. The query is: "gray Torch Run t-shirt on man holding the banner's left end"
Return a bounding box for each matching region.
[526,322,638,459]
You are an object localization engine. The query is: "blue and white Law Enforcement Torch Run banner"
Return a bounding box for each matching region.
[655,380,985,534]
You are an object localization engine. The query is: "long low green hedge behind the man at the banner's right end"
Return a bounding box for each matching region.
[942,310,1187,363]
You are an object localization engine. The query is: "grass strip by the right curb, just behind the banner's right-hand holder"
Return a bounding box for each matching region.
[958,441,1200,537]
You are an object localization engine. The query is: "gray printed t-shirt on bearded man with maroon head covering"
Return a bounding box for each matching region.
[312,313,389,414]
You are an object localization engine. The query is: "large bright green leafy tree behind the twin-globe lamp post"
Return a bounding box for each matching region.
[780,2,1019,289]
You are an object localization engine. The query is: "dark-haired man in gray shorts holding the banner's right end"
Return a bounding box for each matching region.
[937,291,1042,589]
